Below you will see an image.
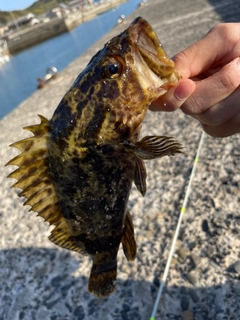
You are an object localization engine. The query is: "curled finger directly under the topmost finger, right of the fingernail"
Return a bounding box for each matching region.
[182,58,240,116]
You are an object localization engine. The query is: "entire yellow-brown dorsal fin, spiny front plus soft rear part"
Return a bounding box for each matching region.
[6,116,85,254]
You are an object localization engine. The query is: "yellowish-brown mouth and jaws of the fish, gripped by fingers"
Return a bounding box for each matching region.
[131,17,181,96]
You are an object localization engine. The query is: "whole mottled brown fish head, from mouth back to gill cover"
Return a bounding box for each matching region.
[53,17,181,143]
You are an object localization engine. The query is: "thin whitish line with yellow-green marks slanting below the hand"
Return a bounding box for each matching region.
[150,132,205,320]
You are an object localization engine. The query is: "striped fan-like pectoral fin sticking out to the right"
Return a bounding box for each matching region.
[126,136,183,160]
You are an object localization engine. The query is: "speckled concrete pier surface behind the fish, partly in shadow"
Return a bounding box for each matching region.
[0,0,240,320]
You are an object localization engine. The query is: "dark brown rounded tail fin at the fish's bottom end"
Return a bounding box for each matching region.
[88,253,117,298]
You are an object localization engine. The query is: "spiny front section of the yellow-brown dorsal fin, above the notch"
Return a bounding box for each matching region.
[6,116,61,224]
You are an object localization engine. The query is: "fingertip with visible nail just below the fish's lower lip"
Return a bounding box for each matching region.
[149,79,196,111]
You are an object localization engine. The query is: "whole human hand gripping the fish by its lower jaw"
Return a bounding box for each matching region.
[150,23,240,137]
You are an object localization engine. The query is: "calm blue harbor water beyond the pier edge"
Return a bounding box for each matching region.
[0,0,140,118]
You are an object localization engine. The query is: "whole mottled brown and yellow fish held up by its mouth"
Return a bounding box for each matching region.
[6,17,183,297]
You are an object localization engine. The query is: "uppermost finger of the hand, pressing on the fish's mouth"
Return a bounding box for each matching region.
[173,23,240,78]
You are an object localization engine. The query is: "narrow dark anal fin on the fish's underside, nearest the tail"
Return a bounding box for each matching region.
[121,211,137,261]
